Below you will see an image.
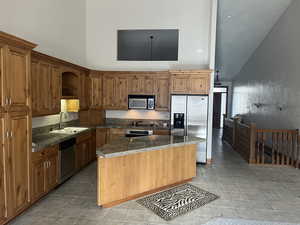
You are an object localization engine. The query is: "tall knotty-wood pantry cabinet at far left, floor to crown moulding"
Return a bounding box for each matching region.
[0,31,36,223]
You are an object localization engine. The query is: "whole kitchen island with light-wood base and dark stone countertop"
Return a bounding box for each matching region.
[97,135,205,207]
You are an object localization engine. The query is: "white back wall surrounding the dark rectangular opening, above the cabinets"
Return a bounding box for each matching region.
[86,0,211,70]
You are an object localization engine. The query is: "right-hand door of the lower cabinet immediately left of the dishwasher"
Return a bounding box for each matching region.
[46,149,58,191]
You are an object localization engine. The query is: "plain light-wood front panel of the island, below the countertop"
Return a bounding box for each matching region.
[98,144,196,207]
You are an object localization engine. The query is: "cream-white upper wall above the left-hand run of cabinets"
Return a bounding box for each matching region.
[0,0,86,66]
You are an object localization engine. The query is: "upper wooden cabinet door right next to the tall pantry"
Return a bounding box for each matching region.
[38,62,51,115]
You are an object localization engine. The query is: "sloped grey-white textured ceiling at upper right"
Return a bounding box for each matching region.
[216,0,292,80]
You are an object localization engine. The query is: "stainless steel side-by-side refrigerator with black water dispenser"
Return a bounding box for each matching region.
[171,95,208,163]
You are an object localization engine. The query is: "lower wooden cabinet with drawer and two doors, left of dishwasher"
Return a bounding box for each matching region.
[31,145,59,201]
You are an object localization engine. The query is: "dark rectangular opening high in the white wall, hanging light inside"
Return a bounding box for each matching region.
[117,29,179,61]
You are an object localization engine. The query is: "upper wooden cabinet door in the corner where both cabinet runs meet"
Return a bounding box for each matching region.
[89,74,102,109]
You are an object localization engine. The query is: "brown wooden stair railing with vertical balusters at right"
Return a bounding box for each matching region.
[222,118,300,168]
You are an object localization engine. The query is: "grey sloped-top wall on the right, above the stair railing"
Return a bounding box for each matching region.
[233,0,300,129]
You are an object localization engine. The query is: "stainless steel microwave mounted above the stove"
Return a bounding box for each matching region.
[128,95,155,110]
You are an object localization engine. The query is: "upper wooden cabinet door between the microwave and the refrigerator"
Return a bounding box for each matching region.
[155,78,170,111]
